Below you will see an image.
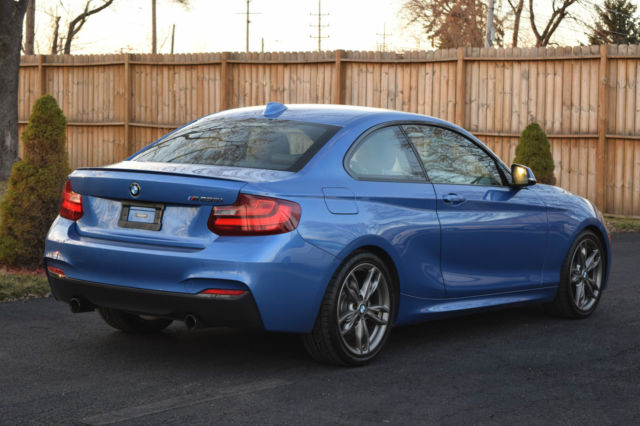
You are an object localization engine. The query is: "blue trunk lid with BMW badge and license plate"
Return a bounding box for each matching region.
[69,161,293,250]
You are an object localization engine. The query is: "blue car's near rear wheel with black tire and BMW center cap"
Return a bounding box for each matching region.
[302,252,397,366]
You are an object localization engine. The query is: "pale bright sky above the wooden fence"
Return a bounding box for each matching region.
[28,0,600,54]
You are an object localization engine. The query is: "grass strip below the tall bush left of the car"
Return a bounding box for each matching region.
[0,268,51,302]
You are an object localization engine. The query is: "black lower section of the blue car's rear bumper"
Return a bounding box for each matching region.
[47,273,263,328]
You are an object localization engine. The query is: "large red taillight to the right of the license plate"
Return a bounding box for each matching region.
[207,194,300,235]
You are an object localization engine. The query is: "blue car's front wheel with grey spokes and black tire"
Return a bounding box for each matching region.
[547,231,606,319]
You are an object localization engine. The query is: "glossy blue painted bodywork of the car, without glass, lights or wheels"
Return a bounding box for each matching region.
[44,104,610,333]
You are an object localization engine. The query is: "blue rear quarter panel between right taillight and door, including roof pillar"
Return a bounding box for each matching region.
[243,114,444,298]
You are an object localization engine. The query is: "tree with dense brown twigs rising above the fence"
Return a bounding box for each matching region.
[404,0,504,49]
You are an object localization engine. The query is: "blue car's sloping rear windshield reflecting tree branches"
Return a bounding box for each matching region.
[132,119,340,172]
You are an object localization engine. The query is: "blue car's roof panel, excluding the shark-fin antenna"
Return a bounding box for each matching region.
[208,104,457,127]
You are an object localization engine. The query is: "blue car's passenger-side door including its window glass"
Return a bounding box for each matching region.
[403,125,547,298]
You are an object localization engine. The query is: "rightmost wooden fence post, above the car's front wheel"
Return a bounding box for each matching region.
[596,44,609,212]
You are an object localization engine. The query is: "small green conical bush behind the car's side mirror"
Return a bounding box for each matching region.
[513,123,556,185]
